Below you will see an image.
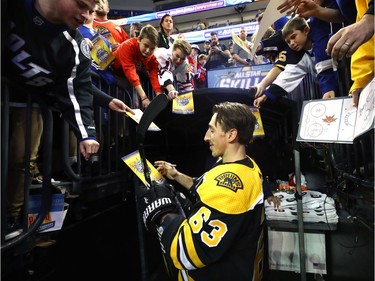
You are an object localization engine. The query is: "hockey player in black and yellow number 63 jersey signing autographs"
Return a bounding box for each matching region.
[138,102,264,281]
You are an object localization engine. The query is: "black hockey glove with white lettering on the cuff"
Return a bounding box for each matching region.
[137,183,177,231]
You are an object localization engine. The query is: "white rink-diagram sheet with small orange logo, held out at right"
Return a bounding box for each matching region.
[297,78,375,144]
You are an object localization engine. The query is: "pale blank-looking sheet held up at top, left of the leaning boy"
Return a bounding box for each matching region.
[251,0,288,54]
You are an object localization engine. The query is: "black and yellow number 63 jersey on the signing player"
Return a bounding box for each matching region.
[161,158,264,281]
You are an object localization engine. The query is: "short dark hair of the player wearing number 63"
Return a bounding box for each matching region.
[212,102,257,145]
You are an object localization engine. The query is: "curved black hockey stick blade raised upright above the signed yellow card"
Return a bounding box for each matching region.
[136,94,169,145]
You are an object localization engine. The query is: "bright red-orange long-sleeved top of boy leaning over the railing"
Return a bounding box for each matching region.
[112,38,163,93]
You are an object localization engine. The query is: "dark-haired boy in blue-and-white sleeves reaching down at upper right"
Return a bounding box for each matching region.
[254,16,338,107]
